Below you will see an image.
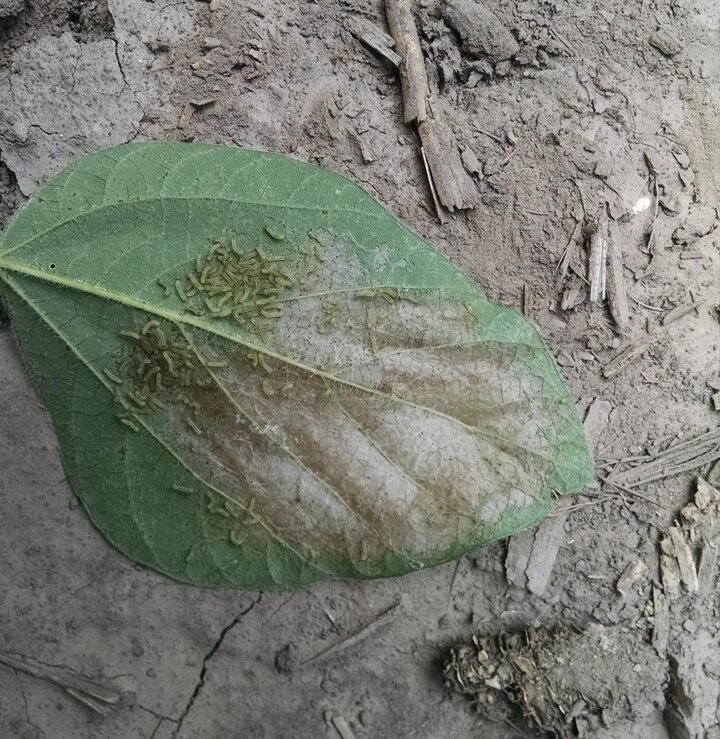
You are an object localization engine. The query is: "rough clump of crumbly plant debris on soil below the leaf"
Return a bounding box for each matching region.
[444,624,662,739]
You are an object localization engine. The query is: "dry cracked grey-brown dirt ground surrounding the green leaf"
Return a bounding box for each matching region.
[0,0,720,739]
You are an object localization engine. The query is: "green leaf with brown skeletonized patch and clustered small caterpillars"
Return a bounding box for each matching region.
[0,143,592,588]
